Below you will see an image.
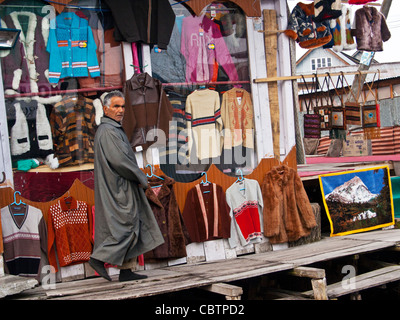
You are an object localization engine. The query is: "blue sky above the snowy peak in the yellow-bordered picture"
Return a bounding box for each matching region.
[321,168,386,195]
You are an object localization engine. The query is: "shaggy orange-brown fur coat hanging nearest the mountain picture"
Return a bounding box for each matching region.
[261,165,317,243]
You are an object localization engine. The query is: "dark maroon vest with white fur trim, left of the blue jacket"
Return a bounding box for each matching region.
[1,11,56,93]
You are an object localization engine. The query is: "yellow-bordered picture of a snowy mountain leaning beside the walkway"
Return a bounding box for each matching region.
[319,166,394,236]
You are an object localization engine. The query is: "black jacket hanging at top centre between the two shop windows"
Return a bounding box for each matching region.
[105,0,175,49]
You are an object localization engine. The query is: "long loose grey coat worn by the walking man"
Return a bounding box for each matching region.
[92,117,164,266]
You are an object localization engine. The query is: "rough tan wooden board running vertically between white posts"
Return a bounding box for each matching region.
[263,10,280,160]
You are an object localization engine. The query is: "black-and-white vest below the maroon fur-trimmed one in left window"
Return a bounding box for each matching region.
[6,100,54,160]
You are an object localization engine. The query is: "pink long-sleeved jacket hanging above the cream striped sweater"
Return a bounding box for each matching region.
[181,16,239,83]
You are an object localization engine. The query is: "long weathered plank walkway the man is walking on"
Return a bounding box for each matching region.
[10,229,400,300]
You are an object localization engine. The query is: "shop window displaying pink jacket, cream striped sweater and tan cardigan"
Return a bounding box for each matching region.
[151,1,255,182]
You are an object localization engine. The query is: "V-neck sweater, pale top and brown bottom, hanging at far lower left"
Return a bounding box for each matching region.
[1,204,47,279]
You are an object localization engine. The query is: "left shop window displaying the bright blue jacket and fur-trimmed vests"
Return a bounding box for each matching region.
[0,0,123,171]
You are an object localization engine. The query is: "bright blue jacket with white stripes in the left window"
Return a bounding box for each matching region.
[47,12,100,83]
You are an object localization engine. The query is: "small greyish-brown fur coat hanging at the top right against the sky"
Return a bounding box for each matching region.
[353,6,391,52]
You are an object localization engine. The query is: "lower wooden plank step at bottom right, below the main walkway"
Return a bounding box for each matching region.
[303,265,400,299]
